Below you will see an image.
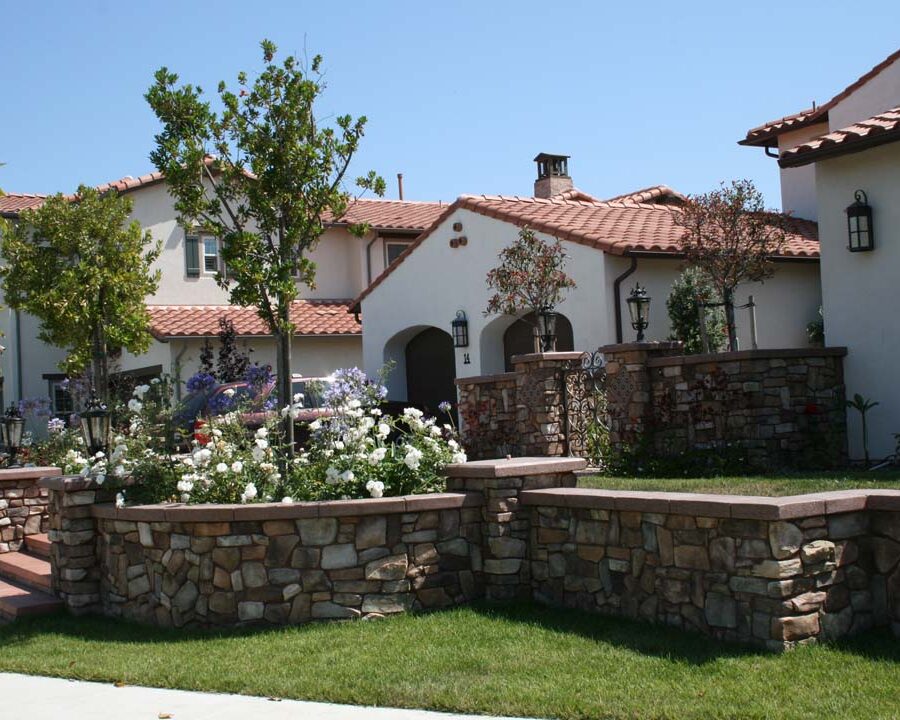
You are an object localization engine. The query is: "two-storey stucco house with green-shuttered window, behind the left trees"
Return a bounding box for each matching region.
[0,172,446,413]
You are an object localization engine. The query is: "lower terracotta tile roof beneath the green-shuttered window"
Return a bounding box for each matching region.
[147,300,362,339]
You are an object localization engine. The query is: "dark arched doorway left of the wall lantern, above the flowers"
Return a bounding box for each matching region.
[406,327,456,417]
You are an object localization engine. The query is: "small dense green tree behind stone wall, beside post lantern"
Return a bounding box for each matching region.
[666,267,725,355]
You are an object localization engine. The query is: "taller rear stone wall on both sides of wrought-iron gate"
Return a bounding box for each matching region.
[457,342,847,469]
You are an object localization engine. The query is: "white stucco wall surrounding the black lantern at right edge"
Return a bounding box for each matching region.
[817,143,900,458]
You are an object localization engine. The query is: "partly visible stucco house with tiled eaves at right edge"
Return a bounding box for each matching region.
[740,50,900,458]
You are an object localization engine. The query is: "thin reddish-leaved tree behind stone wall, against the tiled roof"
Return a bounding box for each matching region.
[674,180,787,350]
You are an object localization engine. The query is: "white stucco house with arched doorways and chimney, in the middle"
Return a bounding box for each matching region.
[352,154,820,414]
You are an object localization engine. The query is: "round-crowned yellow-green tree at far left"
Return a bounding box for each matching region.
[0,185,160,399]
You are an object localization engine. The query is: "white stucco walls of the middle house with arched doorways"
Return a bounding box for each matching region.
[362,210,820,400]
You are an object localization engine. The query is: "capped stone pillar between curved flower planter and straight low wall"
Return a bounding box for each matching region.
[444,457,587,601]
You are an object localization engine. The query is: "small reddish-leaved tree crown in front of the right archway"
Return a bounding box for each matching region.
[485,228,575,315]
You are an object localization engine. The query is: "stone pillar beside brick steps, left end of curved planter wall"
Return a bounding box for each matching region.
[38,475,116,613]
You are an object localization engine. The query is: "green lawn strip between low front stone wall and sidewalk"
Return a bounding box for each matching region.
[0,605,900,720]
